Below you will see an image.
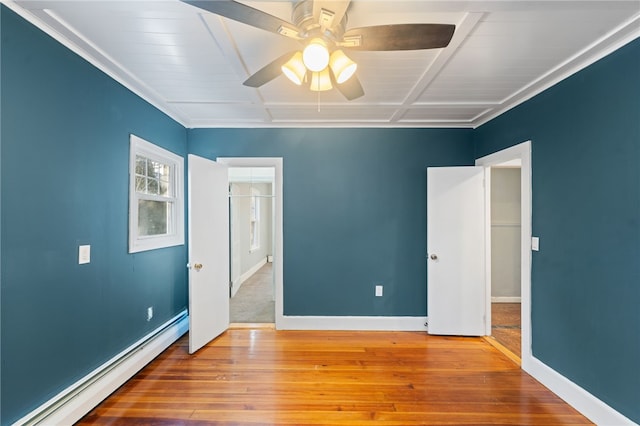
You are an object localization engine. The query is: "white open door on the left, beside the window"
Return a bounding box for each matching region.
[188,154,229,353]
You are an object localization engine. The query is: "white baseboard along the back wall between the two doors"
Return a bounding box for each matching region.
[276,315,427,331]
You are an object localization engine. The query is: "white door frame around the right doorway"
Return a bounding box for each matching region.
[476,140,533,370]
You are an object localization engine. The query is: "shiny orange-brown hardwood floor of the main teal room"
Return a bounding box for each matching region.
[78,328,590,425]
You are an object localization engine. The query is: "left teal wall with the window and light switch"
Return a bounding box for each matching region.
[0,6,187,425]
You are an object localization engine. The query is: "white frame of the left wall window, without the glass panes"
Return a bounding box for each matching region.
[129,135,184,253]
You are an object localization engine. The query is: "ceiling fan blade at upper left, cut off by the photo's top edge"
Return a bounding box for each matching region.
[181,0,302,40]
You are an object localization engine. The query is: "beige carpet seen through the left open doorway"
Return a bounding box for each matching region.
[229,263,275,323]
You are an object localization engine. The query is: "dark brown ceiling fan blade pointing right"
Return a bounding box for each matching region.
[344,24,456,51]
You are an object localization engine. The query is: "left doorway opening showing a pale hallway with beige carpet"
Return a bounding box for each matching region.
[229,167,275,324]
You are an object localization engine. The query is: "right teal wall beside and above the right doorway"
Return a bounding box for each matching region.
[474,39,640,423]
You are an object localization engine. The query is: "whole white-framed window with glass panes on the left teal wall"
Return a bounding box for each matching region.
[129,135,184,253]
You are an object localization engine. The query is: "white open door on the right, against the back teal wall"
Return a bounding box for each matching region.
[427,167,486,336]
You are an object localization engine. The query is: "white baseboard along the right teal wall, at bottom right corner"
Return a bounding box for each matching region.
[522,357,636,426]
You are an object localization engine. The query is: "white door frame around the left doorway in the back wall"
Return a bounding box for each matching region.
[216,157,284,329]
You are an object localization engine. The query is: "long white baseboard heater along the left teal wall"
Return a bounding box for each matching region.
[14,310,189,425]
